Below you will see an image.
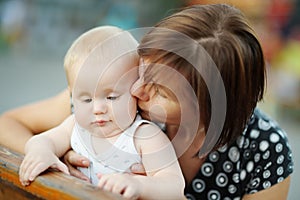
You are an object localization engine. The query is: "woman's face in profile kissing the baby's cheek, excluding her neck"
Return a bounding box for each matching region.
[131,59,199,125]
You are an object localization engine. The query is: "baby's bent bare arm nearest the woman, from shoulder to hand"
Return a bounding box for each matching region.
[99,124,185,199]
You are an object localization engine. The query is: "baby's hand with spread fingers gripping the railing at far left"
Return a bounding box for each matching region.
[19,151,69,186]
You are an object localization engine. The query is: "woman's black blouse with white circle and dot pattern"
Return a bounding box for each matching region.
[185,109,294,200]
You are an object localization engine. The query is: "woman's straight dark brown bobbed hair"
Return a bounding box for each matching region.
[138,4,265,148]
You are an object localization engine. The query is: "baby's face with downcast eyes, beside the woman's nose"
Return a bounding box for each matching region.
[73,53,138,137]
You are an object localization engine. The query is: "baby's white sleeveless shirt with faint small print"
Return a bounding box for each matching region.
[71,115,152,185]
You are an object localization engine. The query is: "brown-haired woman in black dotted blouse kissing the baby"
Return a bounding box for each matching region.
[1,4,293,199]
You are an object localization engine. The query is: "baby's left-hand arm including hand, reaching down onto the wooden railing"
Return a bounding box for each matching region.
[19,116,74,186]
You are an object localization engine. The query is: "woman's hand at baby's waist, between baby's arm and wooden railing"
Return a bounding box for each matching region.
[63,150,90,182]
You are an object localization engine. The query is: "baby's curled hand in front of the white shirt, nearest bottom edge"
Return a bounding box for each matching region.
[97,173,141,199]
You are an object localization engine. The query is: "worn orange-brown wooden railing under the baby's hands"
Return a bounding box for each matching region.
[0,145,122,200]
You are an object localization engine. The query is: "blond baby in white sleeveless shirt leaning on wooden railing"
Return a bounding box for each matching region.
[19,26,185,199]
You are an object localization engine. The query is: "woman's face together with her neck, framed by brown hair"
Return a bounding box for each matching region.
[131,60,204,157]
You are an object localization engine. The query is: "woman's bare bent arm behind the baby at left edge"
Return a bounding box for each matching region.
[0,89,71,153]
